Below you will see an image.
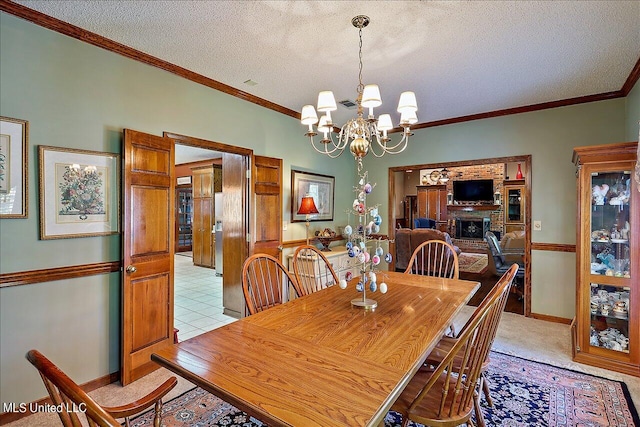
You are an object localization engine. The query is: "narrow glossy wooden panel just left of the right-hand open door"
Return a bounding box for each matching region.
[222,153,249,317]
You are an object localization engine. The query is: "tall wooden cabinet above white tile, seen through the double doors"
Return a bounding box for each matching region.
[192,165,222,268]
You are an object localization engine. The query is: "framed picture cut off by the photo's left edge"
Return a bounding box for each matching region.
[0,117,29,218]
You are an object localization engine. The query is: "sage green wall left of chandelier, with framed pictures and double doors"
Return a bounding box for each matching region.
[0,13,353,408]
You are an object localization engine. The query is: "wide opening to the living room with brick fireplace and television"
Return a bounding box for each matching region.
[388,155,531,316]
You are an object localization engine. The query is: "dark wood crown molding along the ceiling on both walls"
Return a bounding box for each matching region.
[0,0,640,132]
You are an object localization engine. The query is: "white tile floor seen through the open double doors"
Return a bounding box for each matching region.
[173,254,236,341]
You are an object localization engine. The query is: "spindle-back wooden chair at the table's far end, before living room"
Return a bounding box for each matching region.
[404,240,460,279]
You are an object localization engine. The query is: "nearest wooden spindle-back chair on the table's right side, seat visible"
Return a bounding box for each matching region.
[391,266,517,427]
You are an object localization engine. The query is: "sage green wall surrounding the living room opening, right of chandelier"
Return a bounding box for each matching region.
[365,99,625,318]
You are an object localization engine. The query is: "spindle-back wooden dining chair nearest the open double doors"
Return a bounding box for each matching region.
[242,254,303,314]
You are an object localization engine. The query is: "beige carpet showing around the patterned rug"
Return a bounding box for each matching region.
[7,306,640,427]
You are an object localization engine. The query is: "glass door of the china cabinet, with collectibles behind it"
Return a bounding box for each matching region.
[589,171,637,353]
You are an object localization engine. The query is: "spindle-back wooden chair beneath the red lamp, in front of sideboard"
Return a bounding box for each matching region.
[292,245,339,295]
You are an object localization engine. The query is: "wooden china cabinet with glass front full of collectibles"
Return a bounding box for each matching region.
[571,142,640,376]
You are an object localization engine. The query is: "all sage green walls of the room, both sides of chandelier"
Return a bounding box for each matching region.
[0,13,640,412]
